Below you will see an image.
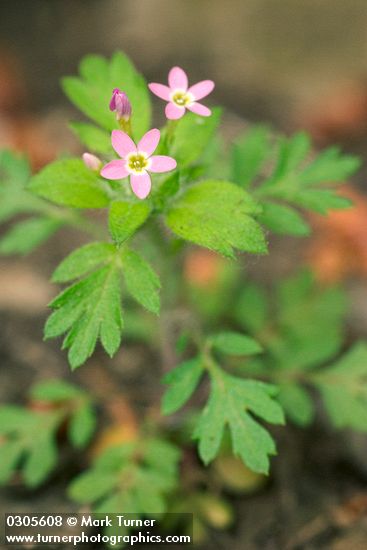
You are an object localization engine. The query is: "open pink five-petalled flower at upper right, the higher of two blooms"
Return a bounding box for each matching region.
[149,67,214,120]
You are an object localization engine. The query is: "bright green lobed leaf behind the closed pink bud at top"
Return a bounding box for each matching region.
[62,52,151,139]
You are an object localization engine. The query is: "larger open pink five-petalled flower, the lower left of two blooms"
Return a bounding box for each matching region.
[101,128,177,199]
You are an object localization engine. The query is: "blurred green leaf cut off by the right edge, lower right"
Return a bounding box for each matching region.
[311,342,367,431]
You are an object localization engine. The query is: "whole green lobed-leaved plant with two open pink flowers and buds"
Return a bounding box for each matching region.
[0,53,367,532]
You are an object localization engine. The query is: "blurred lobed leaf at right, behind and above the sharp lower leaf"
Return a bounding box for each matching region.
[235,271,346,426]
